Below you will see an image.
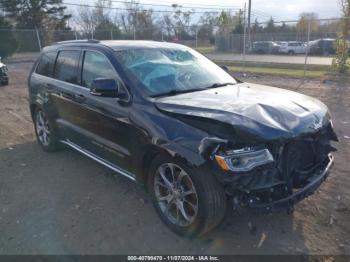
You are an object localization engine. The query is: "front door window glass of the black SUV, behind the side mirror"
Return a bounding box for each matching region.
[82,51,117,88]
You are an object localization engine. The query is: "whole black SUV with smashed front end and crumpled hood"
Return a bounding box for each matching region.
[28,40,337,235]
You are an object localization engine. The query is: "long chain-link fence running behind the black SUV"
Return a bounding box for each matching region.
[0,19,350,78]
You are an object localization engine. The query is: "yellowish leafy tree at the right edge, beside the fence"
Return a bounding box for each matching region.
[333,0,350,73]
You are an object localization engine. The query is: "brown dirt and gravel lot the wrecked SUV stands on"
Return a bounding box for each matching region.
[0,63,350,255]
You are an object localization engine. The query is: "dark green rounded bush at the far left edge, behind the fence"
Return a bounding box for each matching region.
[0,15,18,58]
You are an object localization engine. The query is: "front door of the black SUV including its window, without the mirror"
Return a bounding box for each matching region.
[68,50,132,171]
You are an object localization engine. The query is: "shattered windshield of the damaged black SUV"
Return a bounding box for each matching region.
[116,48,236,96]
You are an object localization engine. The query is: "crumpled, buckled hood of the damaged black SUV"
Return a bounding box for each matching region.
[155,83,330,140]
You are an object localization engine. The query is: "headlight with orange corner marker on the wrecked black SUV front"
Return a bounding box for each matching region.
[215,148,274,172]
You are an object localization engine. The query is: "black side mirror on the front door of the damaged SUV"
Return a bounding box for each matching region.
[90,78,121,97]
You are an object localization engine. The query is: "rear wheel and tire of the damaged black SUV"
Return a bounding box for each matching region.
[33,109,62,152]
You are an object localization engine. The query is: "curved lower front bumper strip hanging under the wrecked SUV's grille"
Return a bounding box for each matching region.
[249,154,334,211]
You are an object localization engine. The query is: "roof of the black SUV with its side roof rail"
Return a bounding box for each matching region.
[56,40,187,51]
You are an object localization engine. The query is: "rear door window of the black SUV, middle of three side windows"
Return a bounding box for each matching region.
[55,51,80,84]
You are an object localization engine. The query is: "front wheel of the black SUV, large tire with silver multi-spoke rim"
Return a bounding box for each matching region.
[147,155,227,237]
